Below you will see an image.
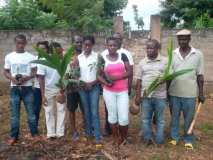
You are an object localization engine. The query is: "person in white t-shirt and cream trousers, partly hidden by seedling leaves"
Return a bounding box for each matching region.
[37,42,65,139]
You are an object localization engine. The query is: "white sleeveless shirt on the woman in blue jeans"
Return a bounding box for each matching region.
[78,51,98,82]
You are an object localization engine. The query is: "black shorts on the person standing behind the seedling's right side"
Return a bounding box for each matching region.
[67,92,84,113]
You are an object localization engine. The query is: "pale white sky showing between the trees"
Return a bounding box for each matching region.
[0,0,160,30]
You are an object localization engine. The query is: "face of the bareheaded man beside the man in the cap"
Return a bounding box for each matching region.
[146,42,158,59]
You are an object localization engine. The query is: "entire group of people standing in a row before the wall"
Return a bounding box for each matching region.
[4,30,204,148]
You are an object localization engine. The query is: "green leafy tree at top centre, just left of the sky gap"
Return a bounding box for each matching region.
[39,0,127,33]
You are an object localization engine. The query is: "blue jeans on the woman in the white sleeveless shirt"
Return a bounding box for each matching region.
[79,85,101,143]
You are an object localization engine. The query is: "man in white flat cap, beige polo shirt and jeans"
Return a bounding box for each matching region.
[169,29,205,149]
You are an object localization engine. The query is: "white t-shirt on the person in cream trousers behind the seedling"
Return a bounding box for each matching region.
[37,64,60,97]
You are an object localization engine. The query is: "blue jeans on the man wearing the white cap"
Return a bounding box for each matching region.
[169,96,196,143]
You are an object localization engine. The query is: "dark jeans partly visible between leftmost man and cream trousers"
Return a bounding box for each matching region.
[33,88,42,130]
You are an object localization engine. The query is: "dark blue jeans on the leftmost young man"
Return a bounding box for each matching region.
[10,86,38,139]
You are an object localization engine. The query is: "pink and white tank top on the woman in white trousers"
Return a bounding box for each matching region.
[104,55,128,92]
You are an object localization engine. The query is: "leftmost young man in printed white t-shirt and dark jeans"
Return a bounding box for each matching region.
[4,34,38,145]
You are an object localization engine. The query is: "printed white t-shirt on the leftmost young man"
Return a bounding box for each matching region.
[4,52,36,86]
